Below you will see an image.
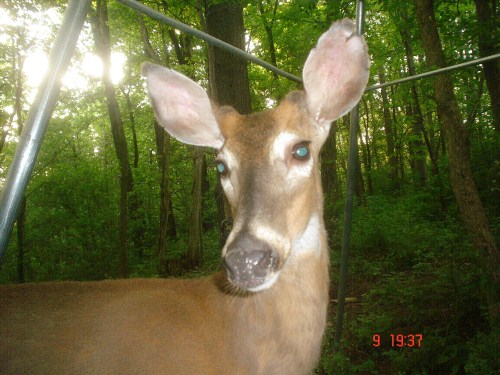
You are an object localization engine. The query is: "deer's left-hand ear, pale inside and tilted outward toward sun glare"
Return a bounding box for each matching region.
[142,63,224,149]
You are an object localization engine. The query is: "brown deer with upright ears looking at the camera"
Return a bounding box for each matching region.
[0,19,370,375]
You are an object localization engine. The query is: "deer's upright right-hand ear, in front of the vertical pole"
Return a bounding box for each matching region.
[302,19,370,124]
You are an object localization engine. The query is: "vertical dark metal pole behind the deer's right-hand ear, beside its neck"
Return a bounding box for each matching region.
[334,0,365,346]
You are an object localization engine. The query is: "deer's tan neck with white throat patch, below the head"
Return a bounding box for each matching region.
[220,210,329,374]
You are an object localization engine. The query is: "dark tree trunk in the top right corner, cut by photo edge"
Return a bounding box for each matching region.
[474,0,500,131]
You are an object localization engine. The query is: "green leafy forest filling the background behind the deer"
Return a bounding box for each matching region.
[0,0,500,374]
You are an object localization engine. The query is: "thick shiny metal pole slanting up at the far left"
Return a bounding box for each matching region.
[0,0,91,264]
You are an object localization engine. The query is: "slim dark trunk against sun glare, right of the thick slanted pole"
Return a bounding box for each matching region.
[92,0,133,277]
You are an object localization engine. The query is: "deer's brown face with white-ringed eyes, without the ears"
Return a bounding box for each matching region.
[217,92,323,291]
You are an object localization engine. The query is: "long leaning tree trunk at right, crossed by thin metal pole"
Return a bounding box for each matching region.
[414,0,498,321]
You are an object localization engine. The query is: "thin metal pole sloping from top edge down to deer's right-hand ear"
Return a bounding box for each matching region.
[117,0,302,83]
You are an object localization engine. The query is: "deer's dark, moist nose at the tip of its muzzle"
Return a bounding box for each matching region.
[224,235,278,290]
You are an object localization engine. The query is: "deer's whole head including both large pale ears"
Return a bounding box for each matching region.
[143,20,369,292]
